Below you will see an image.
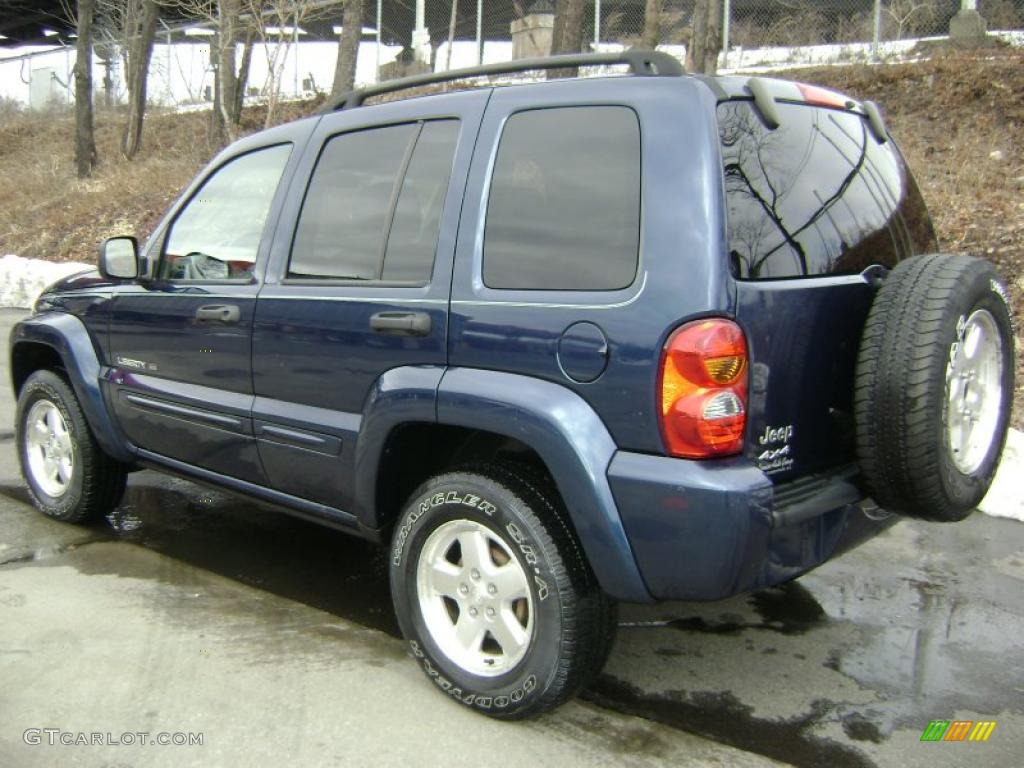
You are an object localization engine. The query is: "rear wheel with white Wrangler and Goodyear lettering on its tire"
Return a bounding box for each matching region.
[390,466,614,719]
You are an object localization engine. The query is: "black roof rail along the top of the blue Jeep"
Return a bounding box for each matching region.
[319,50,686,113]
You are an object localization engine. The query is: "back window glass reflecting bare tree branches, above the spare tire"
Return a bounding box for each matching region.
[718,101,934,280]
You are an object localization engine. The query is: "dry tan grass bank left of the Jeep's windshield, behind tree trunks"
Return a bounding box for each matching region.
[0,103,313,262]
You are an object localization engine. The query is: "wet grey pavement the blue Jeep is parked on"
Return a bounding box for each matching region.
[0,312,1024,768]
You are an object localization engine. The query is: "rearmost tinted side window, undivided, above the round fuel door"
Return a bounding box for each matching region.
[483,106,640,291]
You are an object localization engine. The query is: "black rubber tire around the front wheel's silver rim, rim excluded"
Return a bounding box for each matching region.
[16,371,127,523]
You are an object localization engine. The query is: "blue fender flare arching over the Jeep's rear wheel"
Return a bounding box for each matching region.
[355,367,652,602]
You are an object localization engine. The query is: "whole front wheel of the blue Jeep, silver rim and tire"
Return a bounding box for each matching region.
[17,371,126,522]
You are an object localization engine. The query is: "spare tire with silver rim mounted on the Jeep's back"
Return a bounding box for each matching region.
[854,254,1014,522]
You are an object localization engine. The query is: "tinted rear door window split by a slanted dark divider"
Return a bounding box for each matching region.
[288,120,459,285]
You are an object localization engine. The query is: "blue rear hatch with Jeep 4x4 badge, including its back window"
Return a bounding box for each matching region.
[718,78,936,481]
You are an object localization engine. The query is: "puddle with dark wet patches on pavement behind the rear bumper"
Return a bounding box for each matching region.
[585,517,1024,768]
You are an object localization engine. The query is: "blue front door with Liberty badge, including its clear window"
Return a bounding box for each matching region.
[108,142,293,484]
